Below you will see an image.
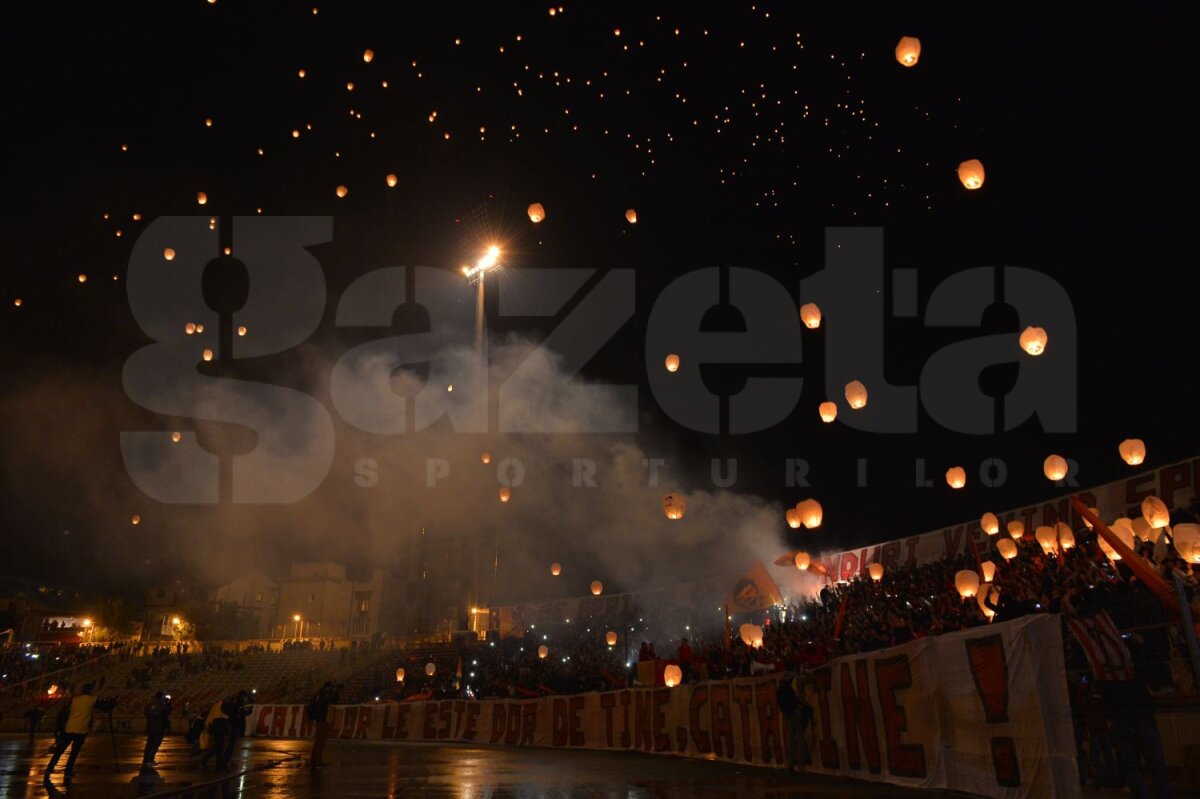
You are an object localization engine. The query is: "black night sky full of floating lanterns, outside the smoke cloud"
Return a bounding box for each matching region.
[0,0,1200,588]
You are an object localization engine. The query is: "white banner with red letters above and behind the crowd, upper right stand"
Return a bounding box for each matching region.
[811,456,1200,579]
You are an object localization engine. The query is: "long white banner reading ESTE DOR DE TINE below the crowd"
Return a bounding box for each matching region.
[250,615,1079,798]
